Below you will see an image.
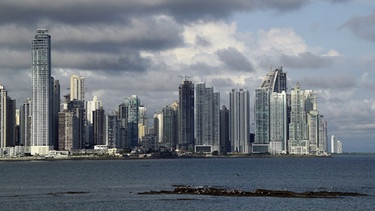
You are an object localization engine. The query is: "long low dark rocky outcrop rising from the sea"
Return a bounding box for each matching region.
[139,185,367,198]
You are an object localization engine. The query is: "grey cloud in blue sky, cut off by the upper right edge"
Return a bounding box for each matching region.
[340,10,375,42]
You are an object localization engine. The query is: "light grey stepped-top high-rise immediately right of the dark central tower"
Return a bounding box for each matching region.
[195,83,220,152]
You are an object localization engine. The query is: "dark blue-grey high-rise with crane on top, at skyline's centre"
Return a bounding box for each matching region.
[177,77,194,151]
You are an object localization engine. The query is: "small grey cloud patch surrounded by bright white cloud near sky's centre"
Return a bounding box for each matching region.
[216,48,254,71]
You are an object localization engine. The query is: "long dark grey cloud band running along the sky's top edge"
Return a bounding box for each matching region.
[0,0,346,26]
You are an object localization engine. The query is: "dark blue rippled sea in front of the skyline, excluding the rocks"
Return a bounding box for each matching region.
[0,156,375,211]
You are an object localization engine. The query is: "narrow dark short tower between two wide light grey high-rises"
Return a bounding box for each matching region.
[220,105,232,153]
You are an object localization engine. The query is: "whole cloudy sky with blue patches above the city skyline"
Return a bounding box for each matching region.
[0,0,375,152]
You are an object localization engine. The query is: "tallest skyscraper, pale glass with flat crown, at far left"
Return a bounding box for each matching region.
[31,29,53,155]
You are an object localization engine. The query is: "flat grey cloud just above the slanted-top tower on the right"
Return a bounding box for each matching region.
[279,52,332,69]
